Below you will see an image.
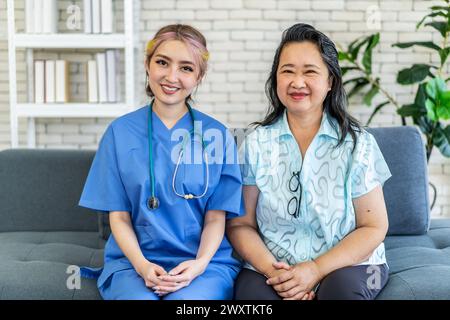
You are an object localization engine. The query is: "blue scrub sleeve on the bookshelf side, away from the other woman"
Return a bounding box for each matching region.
[79,126,131,212]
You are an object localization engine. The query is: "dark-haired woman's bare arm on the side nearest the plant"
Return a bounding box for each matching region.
[315,186,389,277]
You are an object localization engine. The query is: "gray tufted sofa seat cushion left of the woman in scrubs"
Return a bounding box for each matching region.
[0,232,104,299]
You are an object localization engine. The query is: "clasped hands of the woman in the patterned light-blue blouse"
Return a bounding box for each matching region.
[266,261,321,300]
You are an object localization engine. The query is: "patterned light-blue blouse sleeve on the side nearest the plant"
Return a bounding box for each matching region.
[351,131,392,198]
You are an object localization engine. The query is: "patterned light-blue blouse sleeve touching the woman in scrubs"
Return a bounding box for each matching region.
[239,131,257,186]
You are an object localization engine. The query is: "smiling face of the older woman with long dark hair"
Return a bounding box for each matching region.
[277,41,331,114]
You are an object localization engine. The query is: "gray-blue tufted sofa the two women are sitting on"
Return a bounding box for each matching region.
[0,127,450,299]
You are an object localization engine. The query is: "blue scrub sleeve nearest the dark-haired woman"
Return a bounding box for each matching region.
[205,130,245,219]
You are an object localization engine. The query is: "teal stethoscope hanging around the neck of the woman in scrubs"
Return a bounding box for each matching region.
[147,100,209,210]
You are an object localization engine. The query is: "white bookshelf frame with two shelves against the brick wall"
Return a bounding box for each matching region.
[7,0,139,148]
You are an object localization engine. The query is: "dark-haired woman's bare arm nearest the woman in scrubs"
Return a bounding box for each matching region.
[226,186,277,277]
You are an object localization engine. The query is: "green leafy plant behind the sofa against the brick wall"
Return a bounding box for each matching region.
[339,0,450,207]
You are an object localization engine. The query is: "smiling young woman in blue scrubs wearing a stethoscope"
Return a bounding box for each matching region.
[80,25,244,300]
